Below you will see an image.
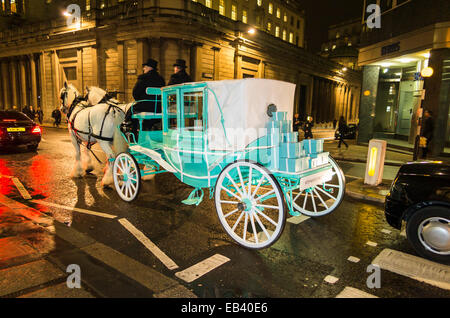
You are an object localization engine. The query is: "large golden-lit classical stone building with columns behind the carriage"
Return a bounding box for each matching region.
[0,0,361,123]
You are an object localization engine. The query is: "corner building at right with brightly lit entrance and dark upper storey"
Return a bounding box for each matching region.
[358,0,450,155]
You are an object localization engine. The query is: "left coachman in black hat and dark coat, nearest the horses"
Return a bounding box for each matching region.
[122,58,166,132]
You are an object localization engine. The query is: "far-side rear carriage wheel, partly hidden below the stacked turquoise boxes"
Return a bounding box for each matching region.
[292,156,345,216]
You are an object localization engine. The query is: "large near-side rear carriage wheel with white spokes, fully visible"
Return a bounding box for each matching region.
[215,161,286,249]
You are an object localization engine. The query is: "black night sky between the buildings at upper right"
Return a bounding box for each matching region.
[303,0,364,53]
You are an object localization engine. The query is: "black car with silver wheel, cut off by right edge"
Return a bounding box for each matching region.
[385,161,450,264]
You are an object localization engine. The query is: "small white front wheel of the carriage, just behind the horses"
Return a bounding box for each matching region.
[113,152,141,202]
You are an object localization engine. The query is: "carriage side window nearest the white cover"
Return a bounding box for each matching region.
[183,92,203,130]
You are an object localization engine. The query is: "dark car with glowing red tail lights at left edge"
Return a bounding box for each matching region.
[0,111,42,151]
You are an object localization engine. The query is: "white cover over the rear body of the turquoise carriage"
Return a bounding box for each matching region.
[206,79,295,150]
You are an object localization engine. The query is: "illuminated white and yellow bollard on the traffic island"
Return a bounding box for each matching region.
[364,139,387,186]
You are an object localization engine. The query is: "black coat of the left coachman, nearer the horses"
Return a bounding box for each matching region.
[133,70,166,113]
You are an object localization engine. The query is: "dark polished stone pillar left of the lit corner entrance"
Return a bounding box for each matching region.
[358,66,380,143]
